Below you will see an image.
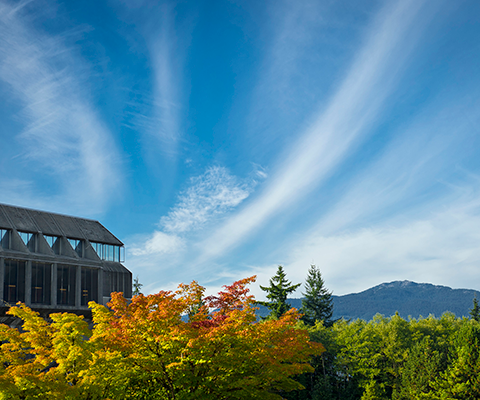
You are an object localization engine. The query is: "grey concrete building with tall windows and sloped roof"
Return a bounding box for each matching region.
[0,204,132,315]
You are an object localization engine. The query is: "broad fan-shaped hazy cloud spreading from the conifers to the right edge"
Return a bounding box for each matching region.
[278,91,480,294]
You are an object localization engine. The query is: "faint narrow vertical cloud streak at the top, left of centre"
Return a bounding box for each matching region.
[117,0,192,161]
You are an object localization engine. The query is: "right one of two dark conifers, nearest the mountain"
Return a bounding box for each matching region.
[300,265,333,326]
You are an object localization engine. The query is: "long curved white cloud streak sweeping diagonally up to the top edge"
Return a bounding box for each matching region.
[200,1,433,262]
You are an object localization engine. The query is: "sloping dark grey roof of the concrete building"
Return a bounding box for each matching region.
[0,204,123,246]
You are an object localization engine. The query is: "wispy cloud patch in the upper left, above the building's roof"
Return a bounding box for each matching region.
[0,2,119,214]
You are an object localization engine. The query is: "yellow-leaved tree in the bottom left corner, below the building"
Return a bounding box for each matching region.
[0,305,103,400]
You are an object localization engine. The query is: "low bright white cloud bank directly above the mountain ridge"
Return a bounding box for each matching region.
[289,195,480,294]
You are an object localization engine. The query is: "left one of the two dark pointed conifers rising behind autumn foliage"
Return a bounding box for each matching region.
[257,265,301,319]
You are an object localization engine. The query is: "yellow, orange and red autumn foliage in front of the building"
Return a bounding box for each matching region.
[0,278,323,400]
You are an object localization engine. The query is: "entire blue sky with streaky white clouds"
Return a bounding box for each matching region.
[0,0,480,299]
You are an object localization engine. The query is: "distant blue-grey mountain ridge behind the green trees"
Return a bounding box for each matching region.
[258,281,480,321]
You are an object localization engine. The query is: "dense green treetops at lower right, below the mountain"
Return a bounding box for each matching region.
[285,313,480,400]
